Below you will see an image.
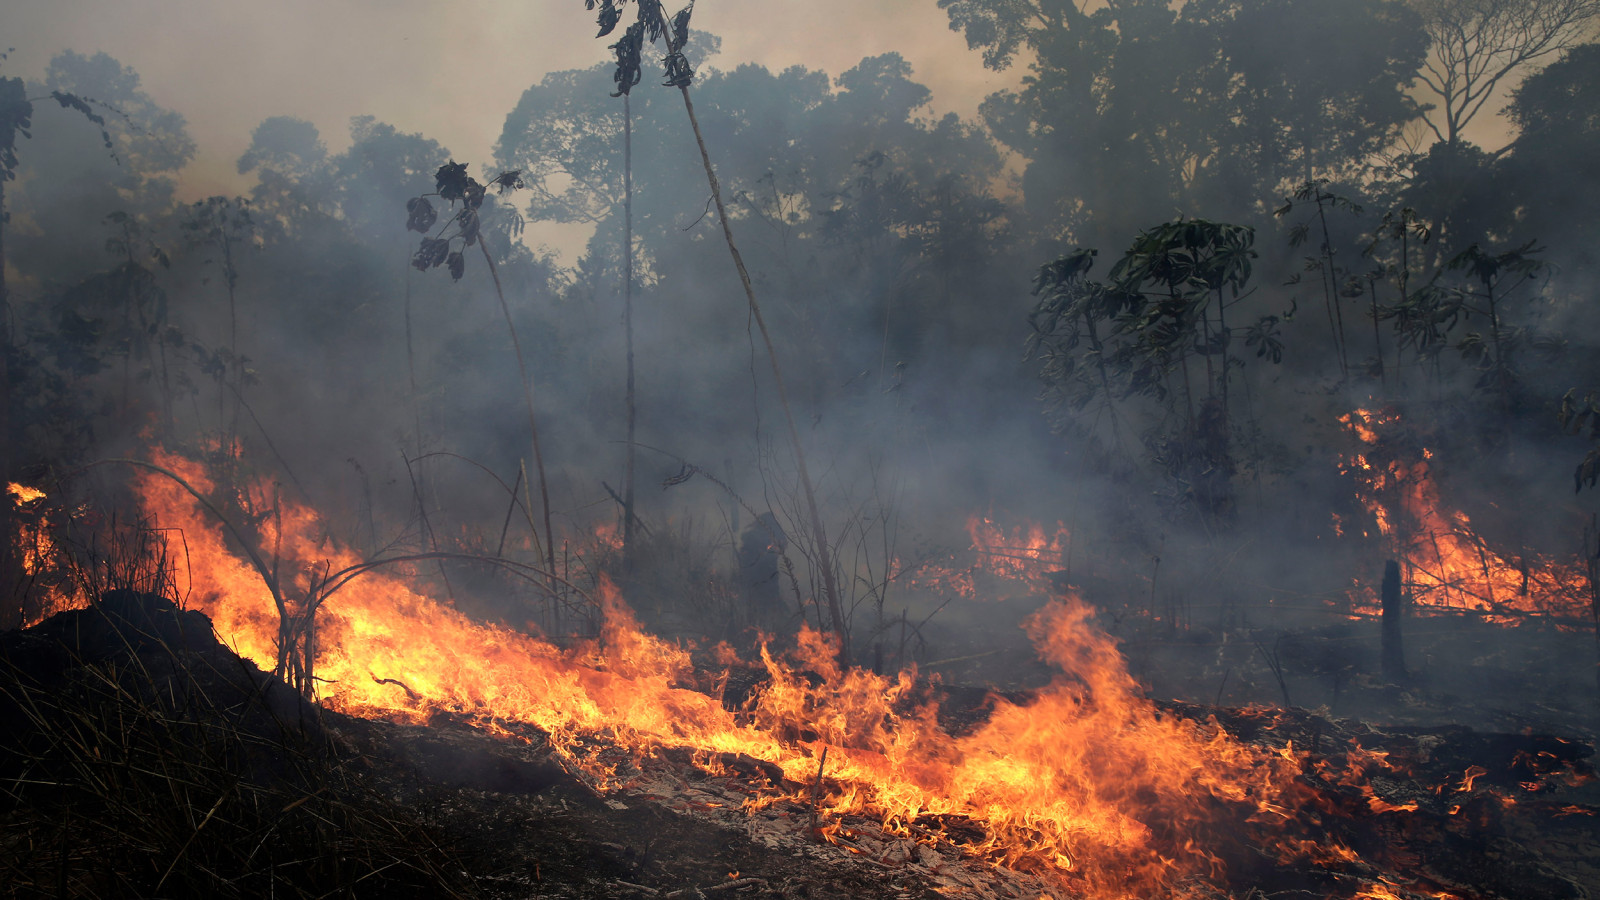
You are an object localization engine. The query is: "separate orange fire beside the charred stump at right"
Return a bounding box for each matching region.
[1339,410,1589,625]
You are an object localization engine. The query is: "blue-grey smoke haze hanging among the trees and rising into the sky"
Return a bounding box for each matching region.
[9,3,1600,736]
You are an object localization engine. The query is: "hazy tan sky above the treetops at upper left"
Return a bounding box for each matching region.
[0,0,1021,199]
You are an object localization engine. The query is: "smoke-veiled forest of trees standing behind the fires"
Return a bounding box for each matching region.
[0,0,1600,666]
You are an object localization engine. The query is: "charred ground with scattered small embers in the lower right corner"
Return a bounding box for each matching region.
[1190,705,1600,900]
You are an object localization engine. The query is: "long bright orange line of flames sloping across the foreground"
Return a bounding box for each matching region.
[121,455,1302,898]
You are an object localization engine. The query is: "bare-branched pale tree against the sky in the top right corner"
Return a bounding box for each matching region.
[1413,0,1600,144]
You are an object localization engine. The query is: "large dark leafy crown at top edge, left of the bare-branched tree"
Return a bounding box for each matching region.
[939,0,1424,240]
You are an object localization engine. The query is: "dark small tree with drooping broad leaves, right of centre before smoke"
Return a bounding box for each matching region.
[1029,219,1282,528]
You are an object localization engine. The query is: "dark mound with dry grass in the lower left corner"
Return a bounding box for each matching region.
[0,594,475,897]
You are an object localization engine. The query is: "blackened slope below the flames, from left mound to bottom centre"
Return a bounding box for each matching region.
[0,591,966,900]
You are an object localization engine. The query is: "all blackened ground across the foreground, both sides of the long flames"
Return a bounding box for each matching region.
[9,591,1600,900]
